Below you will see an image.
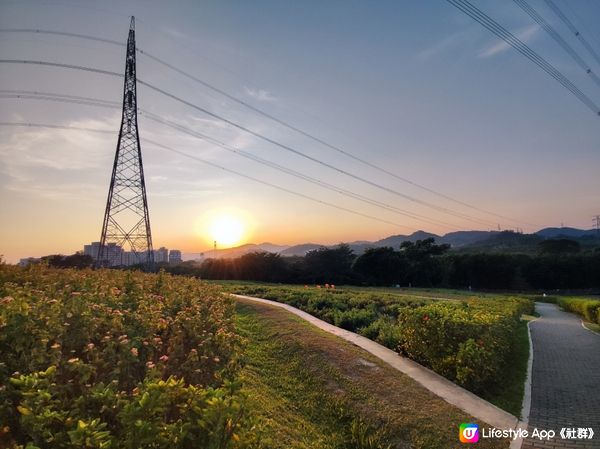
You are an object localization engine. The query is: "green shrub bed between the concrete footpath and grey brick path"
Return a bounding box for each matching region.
[226,284,533,396]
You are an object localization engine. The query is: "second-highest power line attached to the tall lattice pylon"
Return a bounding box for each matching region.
[0,59,502,226]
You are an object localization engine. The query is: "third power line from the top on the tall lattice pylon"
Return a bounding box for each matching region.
[0,90,456,228]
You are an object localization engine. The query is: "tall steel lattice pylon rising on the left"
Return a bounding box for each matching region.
[97,17,154,268]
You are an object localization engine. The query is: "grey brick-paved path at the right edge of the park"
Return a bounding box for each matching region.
[522,303,600,449]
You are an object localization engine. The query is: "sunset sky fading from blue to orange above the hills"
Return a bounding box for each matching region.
[0,0,600,262]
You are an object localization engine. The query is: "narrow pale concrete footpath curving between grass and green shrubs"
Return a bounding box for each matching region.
[233,295,525,440]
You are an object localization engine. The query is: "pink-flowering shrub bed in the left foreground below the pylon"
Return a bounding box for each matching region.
[0,264,254,449]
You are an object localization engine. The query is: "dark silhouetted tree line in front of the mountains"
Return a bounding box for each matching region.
[164,238,600,290]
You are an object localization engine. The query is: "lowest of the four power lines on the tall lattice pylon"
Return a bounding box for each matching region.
[0,122,414,230]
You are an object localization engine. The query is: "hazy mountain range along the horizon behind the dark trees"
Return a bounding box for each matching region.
[183,227,600,260]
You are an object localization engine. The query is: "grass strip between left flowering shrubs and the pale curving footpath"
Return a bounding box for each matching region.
[236,300,508,449]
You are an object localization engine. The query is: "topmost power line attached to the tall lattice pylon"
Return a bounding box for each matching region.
[0,28,520,226]
